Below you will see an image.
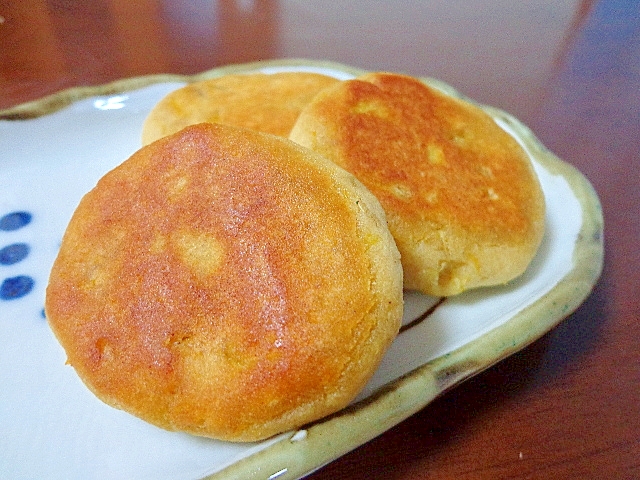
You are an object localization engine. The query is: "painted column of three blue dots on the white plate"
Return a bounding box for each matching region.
[0,212,35,300]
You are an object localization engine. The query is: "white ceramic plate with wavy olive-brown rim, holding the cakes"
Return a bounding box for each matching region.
[0,60,603,479]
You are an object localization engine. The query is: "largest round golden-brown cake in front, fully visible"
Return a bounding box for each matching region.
[46,124,403,441]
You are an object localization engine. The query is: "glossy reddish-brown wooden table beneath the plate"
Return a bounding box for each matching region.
[0,0,640,480]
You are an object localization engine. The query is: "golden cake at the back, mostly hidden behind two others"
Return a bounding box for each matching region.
[142,72,338,145]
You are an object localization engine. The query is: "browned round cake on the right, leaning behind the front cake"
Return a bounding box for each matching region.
[289,72,545,296]
